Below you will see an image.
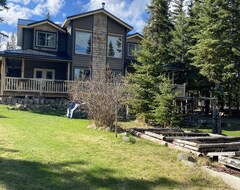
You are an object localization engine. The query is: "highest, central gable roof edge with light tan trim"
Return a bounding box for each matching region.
[62,8,133,30]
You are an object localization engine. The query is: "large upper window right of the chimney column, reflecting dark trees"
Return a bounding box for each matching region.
[107,36,122,58]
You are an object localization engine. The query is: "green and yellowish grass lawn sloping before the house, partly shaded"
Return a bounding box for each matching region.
[0,105,232,190]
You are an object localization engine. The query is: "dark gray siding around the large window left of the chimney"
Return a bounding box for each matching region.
[71,16,93,73]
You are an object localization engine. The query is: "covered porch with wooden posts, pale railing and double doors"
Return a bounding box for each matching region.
[0,50,72,97]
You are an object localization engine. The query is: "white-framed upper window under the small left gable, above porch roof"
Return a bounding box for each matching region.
[37,31,57,48]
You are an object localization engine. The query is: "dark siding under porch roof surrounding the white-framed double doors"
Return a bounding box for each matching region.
[24,60,67,80]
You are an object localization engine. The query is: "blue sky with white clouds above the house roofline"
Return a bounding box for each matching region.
[0,0,150,34]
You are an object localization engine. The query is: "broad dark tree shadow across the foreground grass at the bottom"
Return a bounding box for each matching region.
[0,159,180,190]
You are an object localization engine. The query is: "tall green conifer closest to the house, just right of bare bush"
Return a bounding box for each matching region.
[128,0,179,126]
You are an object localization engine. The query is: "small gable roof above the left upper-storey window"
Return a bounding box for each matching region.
[18,19,65,32]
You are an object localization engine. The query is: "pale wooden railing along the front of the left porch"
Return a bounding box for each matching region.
[3,77,72,94]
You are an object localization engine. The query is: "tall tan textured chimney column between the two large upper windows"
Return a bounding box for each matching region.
[92,13,107,73]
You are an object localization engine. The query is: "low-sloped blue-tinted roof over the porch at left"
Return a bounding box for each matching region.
[0,49,71,61]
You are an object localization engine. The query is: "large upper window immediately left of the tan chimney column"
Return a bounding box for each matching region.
[75,31,92,55]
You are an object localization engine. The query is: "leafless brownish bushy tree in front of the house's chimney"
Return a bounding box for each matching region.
[69,68,126,135]
